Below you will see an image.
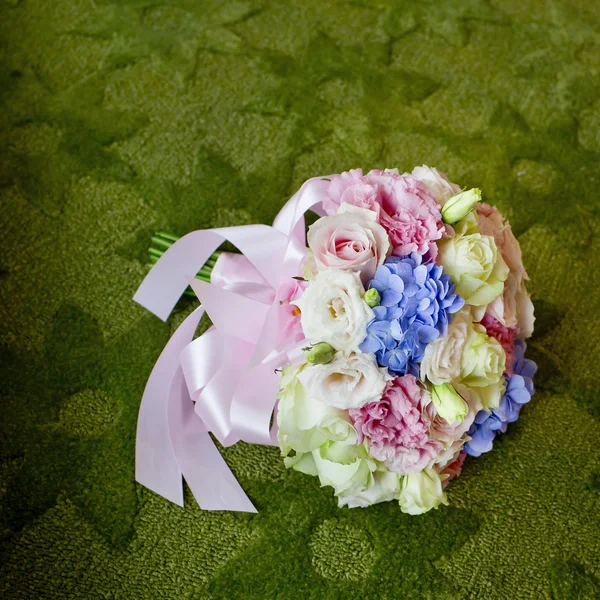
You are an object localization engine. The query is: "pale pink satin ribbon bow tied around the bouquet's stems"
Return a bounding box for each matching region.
[134,177,327,512]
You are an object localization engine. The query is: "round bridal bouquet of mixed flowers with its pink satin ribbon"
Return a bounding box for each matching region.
[136,166,536,514]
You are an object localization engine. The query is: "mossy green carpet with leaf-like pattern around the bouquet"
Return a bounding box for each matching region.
[0,0,600,600]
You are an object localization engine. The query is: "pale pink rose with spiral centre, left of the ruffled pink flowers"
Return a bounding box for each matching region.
[308,204,390,284]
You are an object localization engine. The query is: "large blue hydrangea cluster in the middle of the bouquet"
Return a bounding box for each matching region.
[360,253,464,376]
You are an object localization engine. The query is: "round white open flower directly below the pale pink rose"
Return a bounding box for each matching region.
[293,269,374,352]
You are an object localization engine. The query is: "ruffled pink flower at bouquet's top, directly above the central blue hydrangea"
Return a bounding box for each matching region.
[366,171,445,256]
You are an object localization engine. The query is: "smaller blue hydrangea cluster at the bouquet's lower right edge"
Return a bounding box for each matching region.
[464,340,537,456]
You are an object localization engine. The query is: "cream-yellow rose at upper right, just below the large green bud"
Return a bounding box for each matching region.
[438,215,509,306]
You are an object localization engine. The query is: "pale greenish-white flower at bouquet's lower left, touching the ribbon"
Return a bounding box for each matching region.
[277,364,357,456]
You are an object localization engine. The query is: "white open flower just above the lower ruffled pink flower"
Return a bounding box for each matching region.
[298,352,393,409]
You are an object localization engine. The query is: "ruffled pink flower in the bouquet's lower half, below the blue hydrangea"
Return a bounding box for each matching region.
[349,375,442,475]
